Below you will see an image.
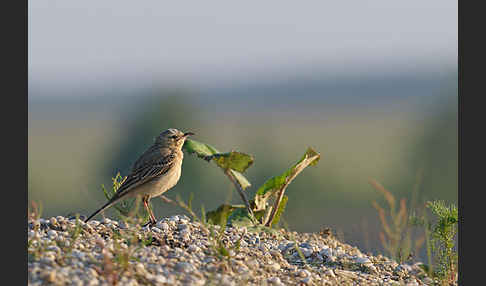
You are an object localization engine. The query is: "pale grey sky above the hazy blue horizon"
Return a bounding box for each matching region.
[28,0,458,92]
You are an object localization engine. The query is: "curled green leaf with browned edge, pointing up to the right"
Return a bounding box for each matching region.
[255,147,321,211]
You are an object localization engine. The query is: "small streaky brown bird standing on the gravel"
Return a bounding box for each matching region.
[85,128,195,225]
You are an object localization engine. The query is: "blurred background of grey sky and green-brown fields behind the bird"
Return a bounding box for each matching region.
[28,0,458,260]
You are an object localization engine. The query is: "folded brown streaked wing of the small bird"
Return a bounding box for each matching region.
[112,153,176,199]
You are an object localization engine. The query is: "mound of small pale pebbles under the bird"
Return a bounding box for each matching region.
[28,215,434,286]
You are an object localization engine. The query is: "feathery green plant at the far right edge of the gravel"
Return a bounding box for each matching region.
[410,201,459,285]
